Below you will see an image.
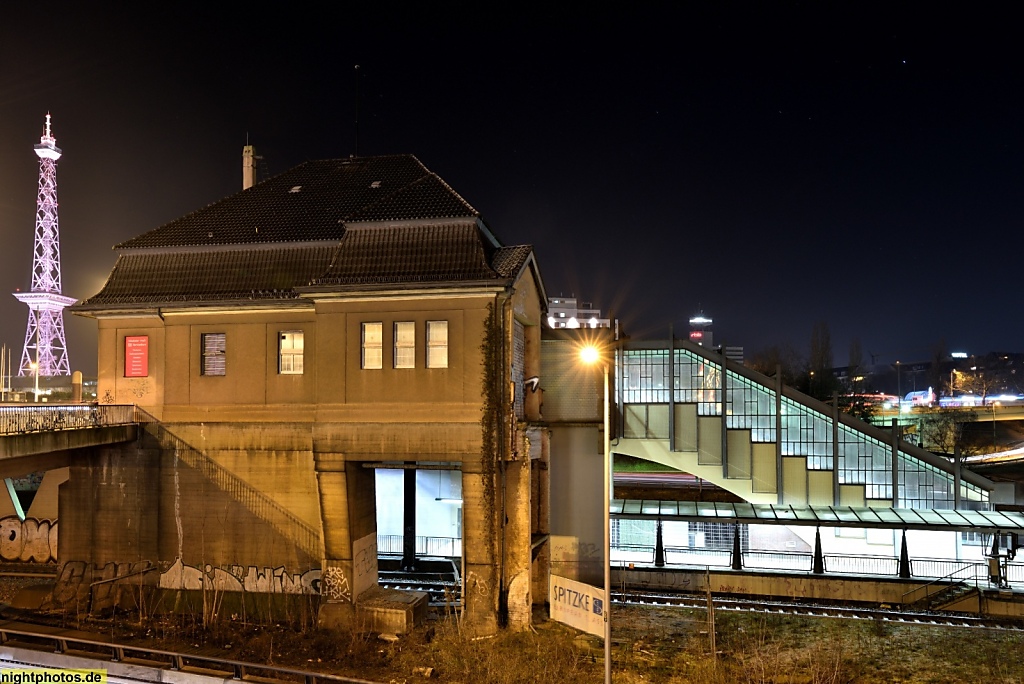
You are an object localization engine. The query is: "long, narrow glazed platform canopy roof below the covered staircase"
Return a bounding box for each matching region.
[610,499,1024,535]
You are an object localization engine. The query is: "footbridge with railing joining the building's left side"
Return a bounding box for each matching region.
[0,403,138,477]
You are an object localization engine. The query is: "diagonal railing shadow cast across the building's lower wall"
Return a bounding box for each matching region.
[139,410,324,558]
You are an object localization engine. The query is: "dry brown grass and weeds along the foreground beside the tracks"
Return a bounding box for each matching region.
[14,607,1024,684]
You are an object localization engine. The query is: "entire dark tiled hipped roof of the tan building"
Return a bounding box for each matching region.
[74,155,532,311]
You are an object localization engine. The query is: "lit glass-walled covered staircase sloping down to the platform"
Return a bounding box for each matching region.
[611,340,994,509]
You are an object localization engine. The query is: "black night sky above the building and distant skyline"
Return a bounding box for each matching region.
[0,2,1024,375]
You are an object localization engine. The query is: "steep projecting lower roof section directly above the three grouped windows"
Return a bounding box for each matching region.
[312,222,501,286]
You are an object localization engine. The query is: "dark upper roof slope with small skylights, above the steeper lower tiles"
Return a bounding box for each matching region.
[117,155,479,249]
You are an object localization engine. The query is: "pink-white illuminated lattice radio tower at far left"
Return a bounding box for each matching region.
[14,114,75,378]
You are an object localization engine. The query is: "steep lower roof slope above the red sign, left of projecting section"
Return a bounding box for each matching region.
[75,243,338,310]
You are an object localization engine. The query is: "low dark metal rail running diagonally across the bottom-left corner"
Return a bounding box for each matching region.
[0,627,381,684]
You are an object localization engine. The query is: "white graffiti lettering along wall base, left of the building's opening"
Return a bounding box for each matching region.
[160,558,321,594]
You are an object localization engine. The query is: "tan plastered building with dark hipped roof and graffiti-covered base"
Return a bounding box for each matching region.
[70,155,548,634]
